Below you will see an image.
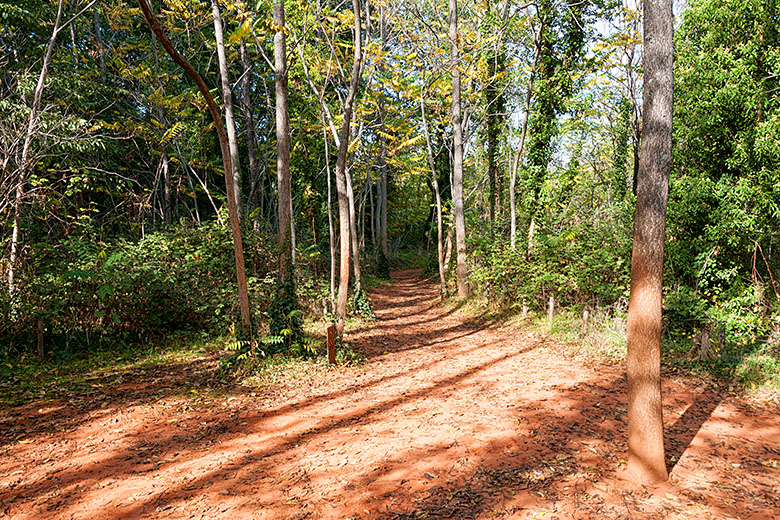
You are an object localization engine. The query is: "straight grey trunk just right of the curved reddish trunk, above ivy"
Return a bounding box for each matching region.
[273,0,294,288]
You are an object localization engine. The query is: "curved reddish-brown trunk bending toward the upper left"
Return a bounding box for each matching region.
[138,0,252,334]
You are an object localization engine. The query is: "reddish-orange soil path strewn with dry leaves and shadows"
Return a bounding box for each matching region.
[0,271,780,520]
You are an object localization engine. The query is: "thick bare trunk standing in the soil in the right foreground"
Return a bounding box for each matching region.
[626,0,673,483]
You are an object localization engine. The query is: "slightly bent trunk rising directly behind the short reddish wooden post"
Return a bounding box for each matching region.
[336,0,363,336]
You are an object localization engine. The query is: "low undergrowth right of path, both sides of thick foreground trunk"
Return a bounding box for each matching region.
[460,210,780,396]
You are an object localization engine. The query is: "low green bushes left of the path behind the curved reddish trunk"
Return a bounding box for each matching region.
[0,223,273,357]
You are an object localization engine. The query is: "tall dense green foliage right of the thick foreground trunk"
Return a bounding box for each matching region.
[665,0,780,384]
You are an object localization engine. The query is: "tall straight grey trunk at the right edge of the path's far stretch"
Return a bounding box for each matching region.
[449,0,469,298]
